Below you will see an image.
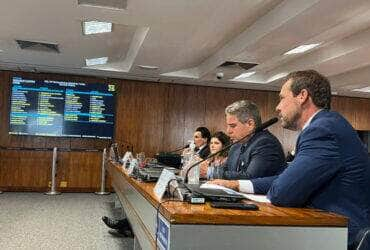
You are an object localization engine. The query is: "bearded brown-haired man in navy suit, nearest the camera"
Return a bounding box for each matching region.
[210,70,370,248]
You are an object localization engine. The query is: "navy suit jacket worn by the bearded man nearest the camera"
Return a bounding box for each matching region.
[251,110,370,245]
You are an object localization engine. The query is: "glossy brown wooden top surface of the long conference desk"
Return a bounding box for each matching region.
[108,162,348,227]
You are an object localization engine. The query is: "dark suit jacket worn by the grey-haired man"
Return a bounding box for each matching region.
[213,130,285,180]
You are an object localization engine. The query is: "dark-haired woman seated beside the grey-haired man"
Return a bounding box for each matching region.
[200,131,230,179]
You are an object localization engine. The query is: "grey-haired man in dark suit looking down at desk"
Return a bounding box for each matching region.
[213,100,285,180]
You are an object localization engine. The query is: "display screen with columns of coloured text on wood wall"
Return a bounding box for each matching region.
[9,77,116,139]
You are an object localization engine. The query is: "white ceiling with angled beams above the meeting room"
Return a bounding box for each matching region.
[0,0,370,98]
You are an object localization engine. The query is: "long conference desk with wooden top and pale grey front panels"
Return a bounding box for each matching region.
[108,162,347,250]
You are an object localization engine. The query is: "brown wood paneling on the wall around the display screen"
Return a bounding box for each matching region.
[0,71,370,191]
